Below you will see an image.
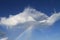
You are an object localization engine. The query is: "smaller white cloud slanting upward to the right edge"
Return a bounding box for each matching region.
[47,13,60,25]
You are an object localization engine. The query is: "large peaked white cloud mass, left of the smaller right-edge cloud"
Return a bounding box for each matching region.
[0,8,48,26]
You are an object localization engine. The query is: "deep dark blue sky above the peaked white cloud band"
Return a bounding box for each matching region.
[0,0,60,16]
